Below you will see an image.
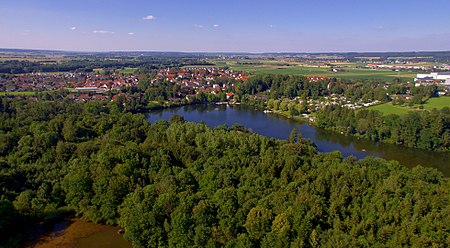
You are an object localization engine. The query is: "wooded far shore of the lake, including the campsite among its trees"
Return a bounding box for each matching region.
[236,75,450,152]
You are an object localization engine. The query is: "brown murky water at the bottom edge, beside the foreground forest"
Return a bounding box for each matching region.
[25,218,132,248]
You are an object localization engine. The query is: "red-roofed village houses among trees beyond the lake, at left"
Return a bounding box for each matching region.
[0,67,248,101]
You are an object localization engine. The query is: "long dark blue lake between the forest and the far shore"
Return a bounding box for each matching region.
[147,105,450,176]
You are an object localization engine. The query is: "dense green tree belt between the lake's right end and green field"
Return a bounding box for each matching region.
[317,106,450,151]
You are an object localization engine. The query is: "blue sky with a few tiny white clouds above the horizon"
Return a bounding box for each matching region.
[0,0,450,52]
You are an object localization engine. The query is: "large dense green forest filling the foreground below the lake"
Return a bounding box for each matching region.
[0,98,450,247]
